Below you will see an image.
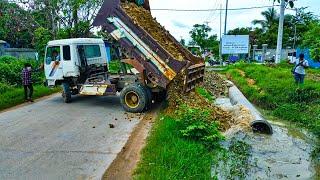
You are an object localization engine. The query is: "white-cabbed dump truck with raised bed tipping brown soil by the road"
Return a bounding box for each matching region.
[45,0,205,113]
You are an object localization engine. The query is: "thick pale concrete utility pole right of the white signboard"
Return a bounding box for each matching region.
[276,0,286,64]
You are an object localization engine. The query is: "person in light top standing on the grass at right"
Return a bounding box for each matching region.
[292,54,309,84]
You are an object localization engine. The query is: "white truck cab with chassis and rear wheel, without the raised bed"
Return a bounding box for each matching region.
[44,38,152,112]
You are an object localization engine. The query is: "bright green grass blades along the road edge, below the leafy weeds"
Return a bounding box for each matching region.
[134,115,215,179]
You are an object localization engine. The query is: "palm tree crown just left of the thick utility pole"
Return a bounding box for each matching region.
[252,8,279,31]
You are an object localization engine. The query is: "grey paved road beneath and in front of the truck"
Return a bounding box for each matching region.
[0,95,139,179]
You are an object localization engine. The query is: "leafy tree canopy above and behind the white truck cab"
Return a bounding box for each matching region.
[0,0,103,53]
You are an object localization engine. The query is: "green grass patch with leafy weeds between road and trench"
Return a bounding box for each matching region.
[134,88,224,179]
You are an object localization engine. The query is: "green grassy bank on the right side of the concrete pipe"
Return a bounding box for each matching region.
[225,63,320,137]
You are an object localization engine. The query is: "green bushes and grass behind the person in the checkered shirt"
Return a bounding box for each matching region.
[0,56,59,111]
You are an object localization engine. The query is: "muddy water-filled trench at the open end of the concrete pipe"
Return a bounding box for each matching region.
[212,98,320,179]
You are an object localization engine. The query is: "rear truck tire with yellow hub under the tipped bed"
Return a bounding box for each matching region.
[120,84,148,113]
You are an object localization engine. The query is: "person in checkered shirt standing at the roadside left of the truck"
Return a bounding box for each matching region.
[21,63,33,102]
